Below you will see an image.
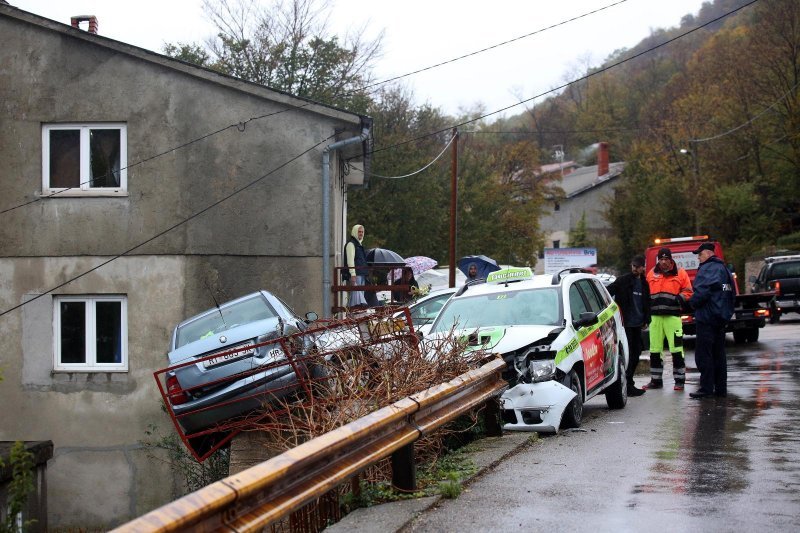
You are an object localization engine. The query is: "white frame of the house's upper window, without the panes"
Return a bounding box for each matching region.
[42,122,128,197]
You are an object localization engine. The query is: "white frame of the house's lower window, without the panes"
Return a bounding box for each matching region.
[53,295,128,372]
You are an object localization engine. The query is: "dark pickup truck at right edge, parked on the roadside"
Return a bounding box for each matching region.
[750,255,800,324]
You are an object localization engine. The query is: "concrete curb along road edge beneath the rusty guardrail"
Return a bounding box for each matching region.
[325,432,533,533]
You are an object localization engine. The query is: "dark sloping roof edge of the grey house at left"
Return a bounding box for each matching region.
[0,1,371,127]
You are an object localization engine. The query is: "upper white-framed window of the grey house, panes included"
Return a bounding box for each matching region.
[42,123,128,196]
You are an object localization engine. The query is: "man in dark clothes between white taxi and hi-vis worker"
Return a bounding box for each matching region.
[608,255,650,396]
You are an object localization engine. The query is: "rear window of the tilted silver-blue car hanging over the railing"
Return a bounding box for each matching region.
[175,294,278,348]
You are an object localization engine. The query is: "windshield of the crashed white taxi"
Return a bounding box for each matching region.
[433,288,562,332]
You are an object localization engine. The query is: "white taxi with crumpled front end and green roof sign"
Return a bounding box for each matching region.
[427,268,628,432]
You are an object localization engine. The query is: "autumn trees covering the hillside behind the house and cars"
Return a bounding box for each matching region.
[165,0,800,271]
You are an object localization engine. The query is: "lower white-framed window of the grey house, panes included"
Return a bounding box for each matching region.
[53,295,128,372]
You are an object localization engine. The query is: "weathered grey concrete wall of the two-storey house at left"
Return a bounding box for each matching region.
[0,5,361,529]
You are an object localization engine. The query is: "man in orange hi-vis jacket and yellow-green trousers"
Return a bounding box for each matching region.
[642,248,692,390]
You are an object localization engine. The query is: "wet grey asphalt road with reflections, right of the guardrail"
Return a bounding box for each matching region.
[407,315,800,532]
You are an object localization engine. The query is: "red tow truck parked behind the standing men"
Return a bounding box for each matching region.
[645,235,773,344]
